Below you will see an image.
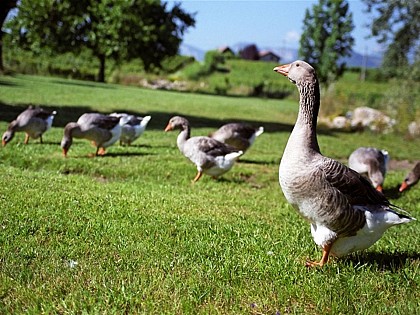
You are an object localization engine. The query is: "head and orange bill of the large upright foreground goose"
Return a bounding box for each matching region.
[273,60,316,85]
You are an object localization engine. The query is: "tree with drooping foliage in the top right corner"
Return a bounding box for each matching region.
[363,0,420,76]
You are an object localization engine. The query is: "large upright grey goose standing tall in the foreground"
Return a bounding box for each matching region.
[273,60,414,267]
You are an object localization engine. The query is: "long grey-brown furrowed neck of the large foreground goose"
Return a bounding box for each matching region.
[294,81,320,152]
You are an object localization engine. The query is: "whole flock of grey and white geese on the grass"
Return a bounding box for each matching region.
[2,60,420,267]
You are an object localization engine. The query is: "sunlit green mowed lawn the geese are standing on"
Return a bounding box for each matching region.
[0,74,420,314]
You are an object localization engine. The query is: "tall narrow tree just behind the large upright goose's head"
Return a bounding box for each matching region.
[299,0,354,85]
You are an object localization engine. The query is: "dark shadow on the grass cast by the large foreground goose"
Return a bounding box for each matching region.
[343,252,420,271]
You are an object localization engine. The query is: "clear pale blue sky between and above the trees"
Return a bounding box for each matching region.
[167,0,381,54]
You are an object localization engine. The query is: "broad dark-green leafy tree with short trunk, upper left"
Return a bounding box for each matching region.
[9,0,195,82]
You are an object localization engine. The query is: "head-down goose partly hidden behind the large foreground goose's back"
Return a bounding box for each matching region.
[349,147,389,192]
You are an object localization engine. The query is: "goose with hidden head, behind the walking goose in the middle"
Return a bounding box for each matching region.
[209,123,264,153]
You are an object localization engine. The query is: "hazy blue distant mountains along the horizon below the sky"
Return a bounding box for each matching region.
[180,43,382,68]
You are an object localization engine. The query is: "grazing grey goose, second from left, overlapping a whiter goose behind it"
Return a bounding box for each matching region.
[61,113,126,157]
